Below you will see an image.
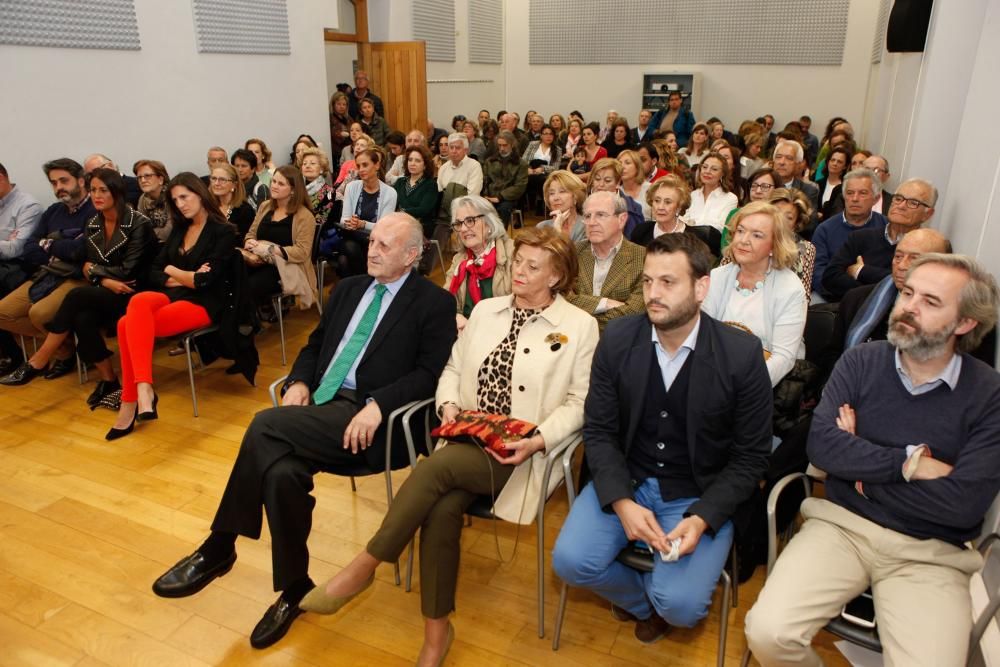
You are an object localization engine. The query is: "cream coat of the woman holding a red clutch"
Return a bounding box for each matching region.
[435,296,599,524]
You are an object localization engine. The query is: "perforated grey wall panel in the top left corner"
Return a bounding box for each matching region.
[0,0,140,51]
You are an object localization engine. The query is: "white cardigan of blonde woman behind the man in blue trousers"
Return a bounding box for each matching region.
[701,262,809,387]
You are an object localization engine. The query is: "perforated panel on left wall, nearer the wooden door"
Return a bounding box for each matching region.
[191,0,292,55]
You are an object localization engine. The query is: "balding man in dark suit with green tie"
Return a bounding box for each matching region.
[153,213,456,648]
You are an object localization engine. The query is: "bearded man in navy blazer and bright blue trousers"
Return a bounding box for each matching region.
[552,234,773,643]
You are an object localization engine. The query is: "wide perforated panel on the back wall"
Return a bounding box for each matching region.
[528,0,850,65]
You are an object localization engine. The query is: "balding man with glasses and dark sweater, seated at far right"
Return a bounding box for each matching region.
[823,178,938,301]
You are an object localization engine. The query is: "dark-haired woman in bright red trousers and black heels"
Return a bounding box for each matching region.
[105,172,237,440]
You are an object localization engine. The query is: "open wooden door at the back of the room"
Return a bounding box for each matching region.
[358,42,427,134]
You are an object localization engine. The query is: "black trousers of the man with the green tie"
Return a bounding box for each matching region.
[212,392,365,591]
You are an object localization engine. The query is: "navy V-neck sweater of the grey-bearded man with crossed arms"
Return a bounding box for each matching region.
[808,341,1000,544]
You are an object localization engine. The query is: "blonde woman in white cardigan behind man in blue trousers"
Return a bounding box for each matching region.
[701,201,809,387]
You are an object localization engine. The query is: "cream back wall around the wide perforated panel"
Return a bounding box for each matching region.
[505,0,879,137]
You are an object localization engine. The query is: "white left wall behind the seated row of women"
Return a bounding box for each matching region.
[0,0,337,202]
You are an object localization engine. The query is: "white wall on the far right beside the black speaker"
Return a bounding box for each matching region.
[868,0,1000,274]
